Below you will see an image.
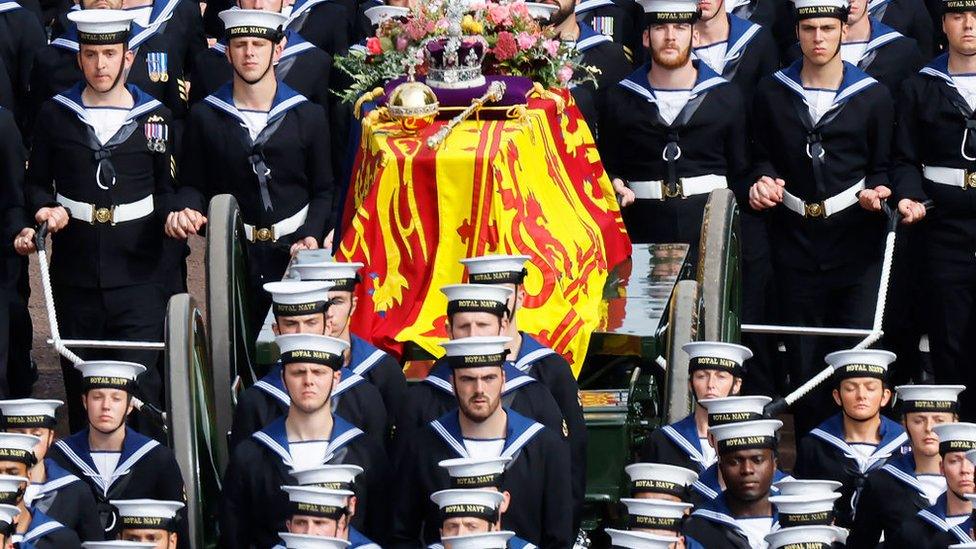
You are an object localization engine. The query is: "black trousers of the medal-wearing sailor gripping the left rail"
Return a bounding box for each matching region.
[53,283,170,438]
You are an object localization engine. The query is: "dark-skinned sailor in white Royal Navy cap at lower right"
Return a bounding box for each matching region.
[684,419,783,549]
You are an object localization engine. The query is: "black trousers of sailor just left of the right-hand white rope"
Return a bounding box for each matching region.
[776,260,881,439]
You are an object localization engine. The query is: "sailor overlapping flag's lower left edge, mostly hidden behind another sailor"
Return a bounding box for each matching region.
[292,255,407,425]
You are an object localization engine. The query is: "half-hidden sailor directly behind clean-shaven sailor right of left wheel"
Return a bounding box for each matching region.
[229,280,389,448]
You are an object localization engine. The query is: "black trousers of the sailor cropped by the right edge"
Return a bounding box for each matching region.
[924,257,976,421]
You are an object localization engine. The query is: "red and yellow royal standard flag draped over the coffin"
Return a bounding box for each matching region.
[337,91,630,373]
